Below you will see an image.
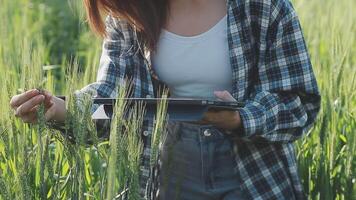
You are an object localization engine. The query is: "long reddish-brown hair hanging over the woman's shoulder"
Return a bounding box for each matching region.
[83,0,169,50]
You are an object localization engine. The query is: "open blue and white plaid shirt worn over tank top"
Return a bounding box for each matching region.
[71,0,321,200]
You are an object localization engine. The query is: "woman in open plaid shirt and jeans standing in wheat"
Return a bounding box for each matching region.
[10,0,321,200]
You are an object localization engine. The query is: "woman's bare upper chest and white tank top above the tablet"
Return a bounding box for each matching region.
[151,0,233,99]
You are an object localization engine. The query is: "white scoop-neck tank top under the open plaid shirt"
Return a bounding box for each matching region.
[152,15,232,100]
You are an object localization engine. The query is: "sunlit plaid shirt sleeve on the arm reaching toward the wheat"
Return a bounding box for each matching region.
[47,15,133,141]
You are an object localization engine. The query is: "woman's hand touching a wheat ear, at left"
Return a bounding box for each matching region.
[10,89,66,123]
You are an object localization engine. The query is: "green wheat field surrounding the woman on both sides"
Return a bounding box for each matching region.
[0,0,356,200]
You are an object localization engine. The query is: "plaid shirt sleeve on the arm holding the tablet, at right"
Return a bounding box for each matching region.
[229,6,321,142]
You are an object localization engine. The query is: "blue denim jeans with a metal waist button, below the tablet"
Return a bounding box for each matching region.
[158,121,242,200]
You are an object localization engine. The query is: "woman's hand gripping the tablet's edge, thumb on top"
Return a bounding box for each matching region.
[198,90,241,130]
